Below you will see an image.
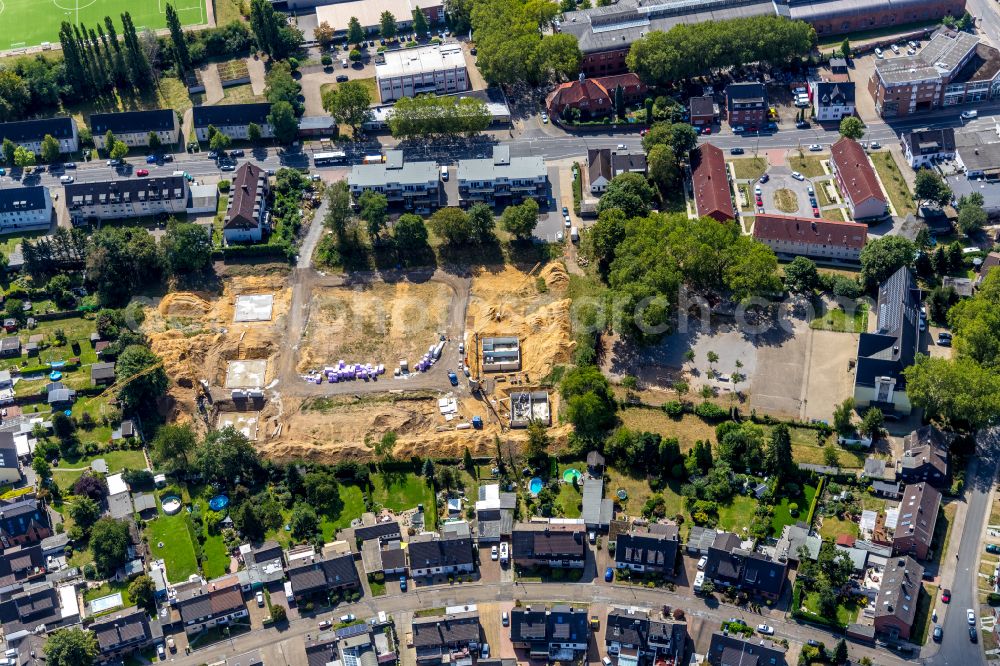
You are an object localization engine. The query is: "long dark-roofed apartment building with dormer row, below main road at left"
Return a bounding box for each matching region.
[65,176,189,220]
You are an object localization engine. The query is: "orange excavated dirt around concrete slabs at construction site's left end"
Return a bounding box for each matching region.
[142,275,291,422]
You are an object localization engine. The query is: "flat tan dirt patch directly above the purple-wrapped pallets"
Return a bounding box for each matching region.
[296,282,453,372]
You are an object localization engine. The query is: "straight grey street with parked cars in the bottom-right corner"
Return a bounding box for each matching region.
[923,430,1000,666]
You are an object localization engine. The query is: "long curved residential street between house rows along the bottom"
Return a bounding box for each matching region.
[164,572,916,666]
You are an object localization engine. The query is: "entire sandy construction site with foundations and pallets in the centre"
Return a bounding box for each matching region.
[157,263,573,462]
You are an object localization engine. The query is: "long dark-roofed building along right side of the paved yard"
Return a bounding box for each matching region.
[854,266,920,390]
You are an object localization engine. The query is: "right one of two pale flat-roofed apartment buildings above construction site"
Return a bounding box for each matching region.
[458,144,549,207]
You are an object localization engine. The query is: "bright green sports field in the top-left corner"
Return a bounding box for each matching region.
[0,0,207,51]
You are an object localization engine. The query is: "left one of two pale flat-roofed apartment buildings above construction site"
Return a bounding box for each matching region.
[347,150,441,213]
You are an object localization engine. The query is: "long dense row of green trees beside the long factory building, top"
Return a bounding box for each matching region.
[625,16,816,86]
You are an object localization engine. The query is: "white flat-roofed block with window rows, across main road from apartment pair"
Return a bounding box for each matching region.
[375,44,469,102]
